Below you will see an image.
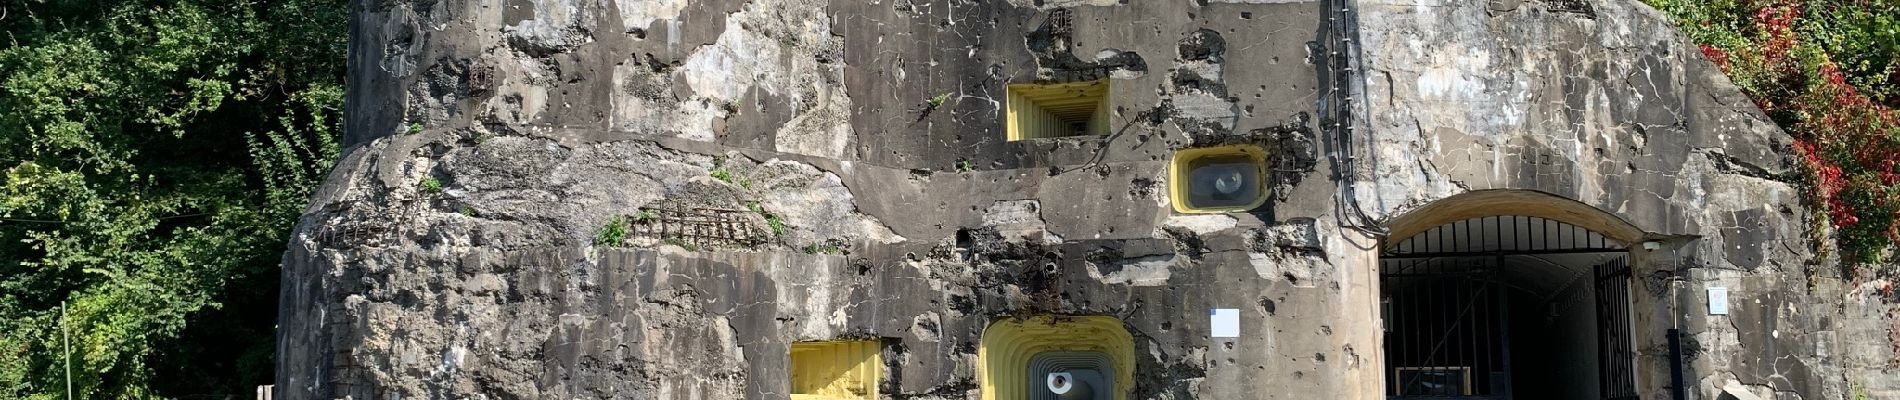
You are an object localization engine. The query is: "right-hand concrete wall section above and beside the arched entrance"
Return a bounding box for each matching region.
[1359,0,1900,398]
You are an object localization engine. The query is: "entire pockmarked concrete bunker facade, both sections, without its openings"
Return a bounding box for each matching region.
[277,0,1900,398]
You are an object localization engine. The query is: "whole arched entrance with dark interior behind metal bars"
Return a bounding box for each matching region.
[1379,215,1636,400]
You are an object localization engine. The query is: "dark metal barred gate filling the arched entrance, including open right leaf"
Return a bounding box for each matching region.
[1379,216,1636,400]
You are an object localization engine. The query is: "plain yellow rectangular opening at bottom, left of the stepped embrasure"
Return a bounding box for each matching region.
[790,341,884,400]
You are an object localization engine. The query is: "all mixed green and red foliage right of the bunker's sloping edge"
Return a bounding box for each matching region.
[1647,0,1900,264]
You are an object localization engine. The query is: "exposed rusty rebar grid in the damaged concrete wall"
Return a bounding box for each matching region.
[629,207,764,246]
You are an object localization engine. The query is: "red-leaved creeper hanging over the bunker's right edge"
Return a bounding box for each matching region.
[1695,0,1900,260]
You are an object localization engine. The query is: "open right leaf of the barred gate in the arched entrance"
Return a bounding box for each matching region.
[1596,258,1642,400]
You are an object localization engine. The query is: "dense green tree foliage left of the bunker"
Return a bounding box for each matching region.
[0,0,348,398]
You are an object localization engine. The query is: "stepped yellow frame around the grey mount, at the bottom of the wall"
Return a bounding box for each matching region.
[977,315,1134,400]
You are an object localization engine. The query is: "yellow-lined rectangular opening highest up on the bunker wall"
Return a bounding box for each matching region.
[1003,80,1110,140]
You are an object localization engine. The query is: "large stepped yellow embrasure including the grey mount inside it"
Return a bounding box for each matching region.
[977,315,1134,400]
